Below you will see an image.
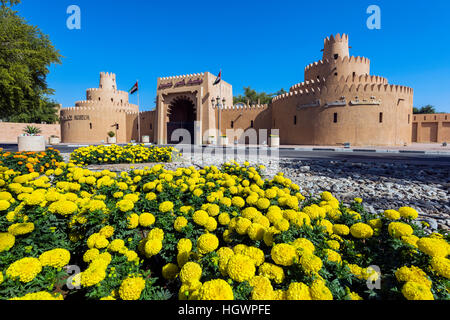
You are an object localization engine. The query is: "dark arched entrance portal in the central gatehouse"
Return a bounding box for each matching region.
[167,96,196,144]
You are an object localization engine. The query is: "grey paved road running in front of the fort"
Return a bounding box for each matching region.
[0,145,450,167]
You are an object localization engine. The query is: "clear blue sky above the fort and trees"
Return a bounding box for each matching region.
[16,0,450,113]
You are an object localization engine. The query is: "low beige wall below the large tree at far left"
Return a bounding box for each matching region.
[0,122,61,143]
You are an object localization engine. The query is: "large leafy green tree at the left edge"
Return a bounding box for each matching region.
[0,0,61,123]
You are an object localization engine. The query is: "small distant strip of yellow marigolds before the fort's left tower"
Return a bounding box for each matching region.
[70,144,180,165]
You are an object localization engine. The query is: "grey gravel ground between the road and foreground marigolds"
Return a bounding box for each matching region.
[64,155,450,230]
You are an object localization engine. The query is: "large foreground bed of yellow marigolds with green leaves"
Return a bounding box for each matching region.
[0,163,450,300]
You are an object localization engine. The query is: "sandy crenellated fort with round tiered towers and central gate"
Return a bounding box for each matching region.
[61,34,424,146]
